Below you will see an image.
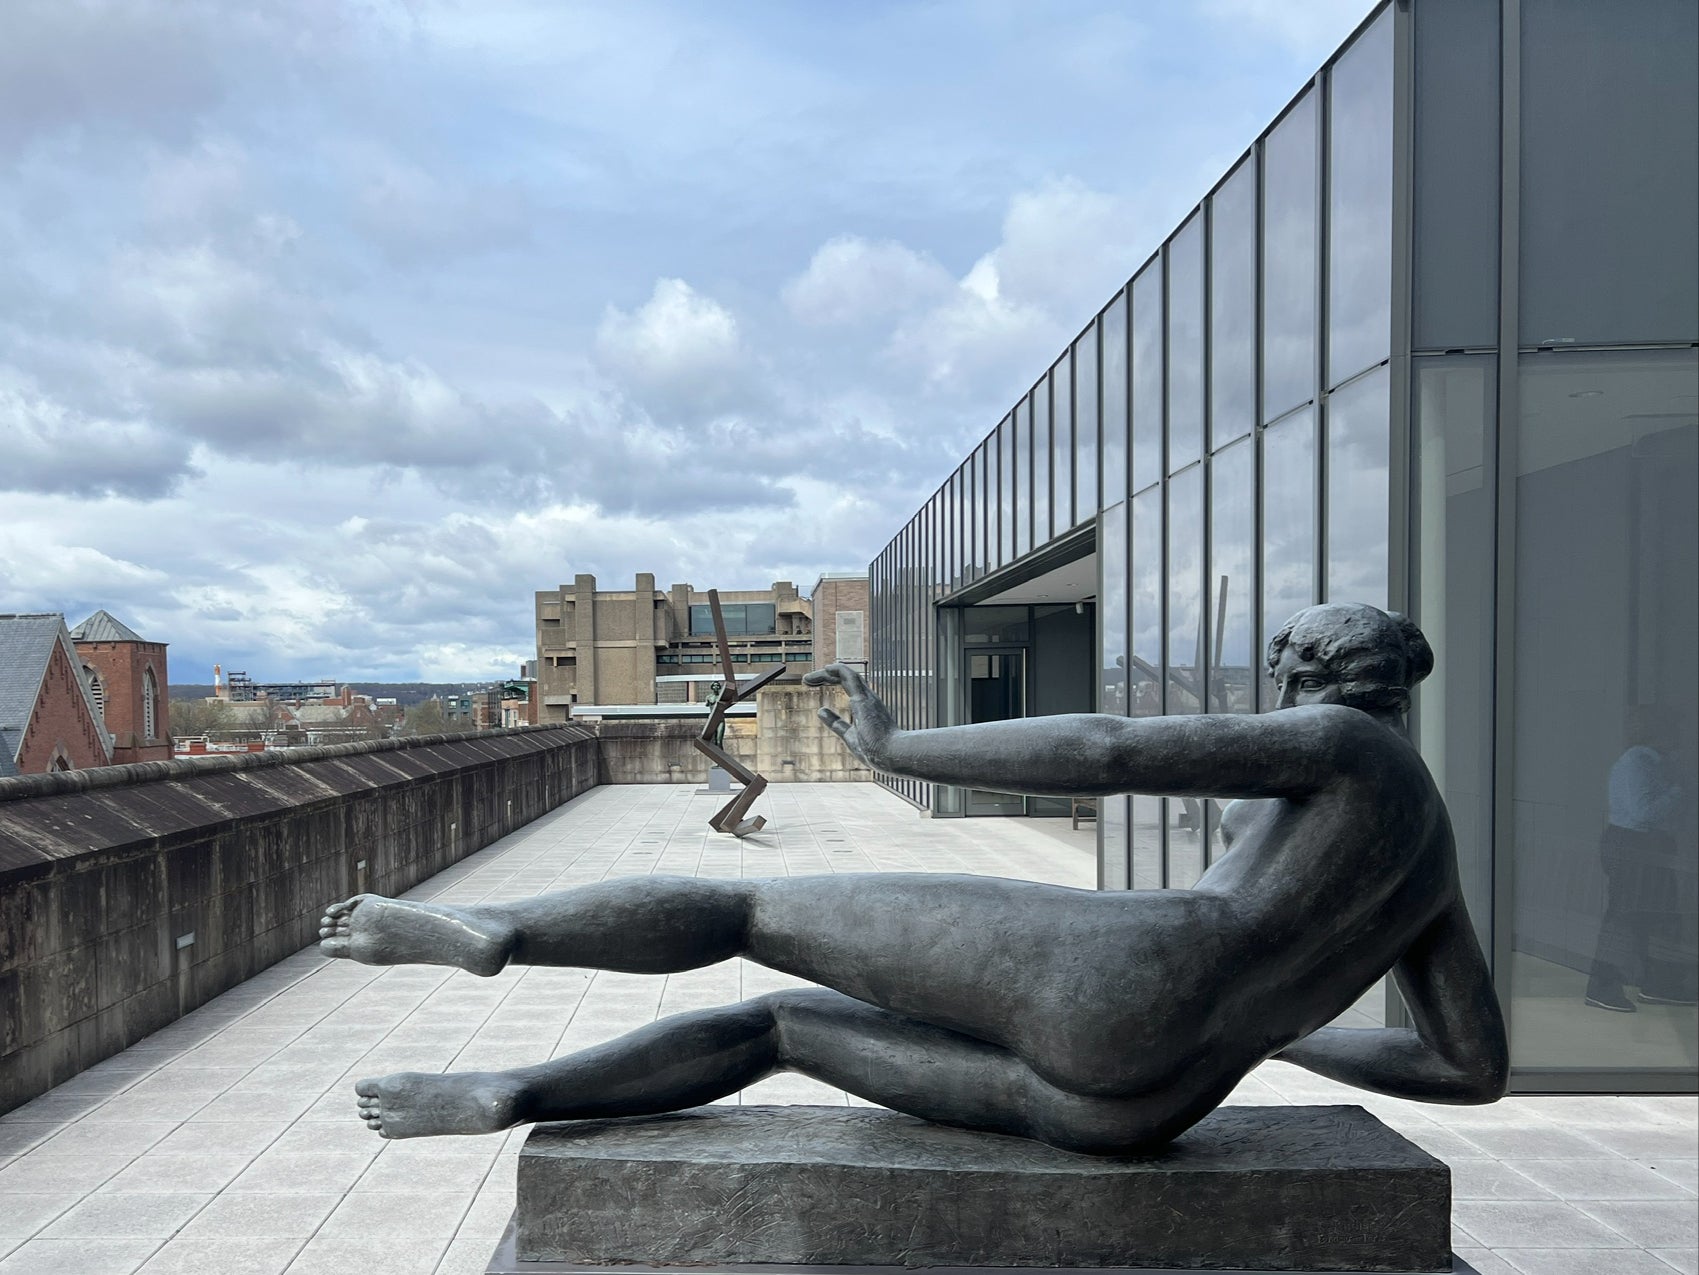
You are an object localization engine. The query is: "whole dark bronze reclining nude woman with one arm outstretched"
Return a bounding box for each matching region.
[321,605,1509,1154]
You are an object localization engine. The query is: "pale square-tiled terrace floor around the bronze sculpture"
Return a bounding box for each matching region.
[0,784,1699,1275]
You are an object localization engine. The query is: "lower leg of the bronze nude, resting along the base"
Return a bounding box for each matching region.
[357,988,1215,1154]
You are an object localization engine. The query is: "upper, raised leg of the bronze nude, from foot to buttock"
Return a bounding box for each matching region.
[321,874,1168,1098]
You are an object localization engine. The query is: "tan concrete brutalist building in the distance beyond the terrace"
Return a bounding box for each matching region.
[537,571,814,723]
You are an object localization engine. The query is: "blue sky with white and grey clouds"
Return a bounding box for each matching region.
[0,0,1369,682]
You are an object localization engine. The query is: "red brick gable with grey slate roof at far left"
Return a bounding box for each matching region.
[0,614,114,777]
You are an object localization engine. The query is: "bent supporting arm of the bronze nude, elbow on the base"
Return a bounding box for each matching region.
[1276,903,1510,1103]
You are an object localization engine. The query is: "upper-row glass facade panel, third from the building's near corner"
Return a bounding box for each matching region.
[1210,155,1257,449]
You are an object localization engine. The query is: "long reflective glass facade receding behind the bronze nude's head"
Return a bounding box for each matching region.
[877,10,1393,887]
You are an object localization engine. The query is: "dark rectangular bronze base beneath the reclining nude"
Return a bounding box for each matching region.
[489,1107,1468,1275]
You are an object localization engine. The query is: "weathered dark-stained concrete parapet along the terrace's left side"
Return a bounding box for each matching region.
[0,726,598,1112]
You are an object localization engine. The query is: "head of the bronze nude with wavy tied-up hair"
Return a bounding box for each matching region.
[1267,602,1434,716]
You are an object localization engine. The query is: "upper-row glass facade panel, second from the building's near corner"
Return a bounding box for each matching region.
[1262,90,1317,430]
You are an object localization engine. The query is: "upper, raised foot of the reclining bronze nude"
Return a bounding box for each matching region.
[319,894,516,976]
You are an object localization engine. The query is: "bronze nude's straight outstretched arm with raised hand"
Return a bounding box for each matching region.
[804,665,1372,799]
